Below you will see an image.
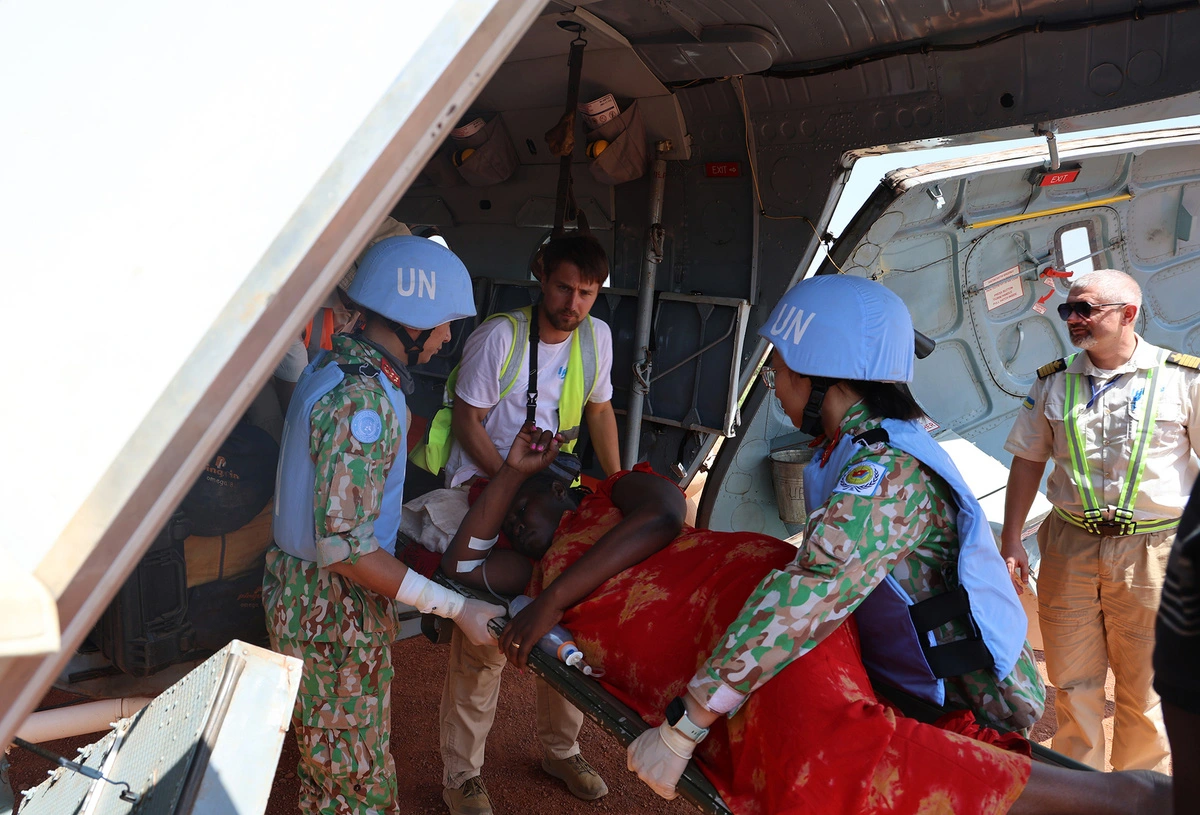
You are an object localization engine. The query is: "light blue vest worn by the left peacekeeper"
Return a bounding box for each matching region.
[272,353,407,562]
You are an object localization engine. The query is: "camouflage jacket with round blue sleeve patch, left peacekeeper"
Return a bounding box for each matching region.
[263,335,404,646]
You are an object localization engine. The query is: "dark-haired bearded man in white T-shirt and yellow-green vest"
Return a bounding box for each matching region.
[440,235,620,815]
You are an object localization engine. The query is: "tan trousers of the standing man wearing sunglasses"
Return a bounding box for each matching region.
[1038,514,1175,772]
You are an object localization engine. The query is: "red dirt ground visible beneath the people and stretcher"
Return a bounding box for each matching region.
[8,637,1171,815]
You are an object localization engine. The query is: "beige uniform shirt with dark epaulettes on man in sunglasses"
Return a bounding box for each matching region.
[1004,336,1200,521]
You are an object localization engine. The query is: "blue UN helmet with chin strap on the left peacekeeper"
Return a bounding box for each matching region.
[346,235,475,365]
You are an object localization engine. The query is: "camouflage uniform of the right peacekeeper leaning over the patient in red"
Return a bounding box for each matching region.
[690,404,1045,731]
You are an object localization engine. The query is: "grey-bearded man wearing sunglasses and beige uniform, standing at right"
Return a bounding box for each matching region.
[1001,269,1200,772]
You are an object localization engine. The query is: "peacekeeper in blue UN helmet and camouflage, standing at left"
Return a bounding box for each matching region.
[263,236,504,815]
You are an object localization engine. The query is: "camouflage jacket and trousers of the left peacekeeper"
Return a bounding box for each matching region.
[263,336,404,815]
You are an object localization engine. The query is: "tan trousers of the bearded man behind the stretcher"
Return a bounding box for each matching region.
[440,627,583,789]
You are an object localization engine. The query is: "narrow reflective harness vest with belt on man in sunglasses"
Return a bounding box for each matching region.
[1060,352,1177,535]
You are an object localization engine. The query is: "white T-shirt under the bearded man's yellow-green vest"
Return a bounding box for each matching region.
[446,312,612,487]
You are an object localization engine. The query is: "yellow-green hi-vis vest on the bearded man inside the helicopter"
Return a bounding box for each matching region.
[409,306,600,475]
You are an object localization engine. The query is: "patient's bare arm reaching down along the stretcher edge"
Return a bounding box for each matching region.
[488,473,686,667]
